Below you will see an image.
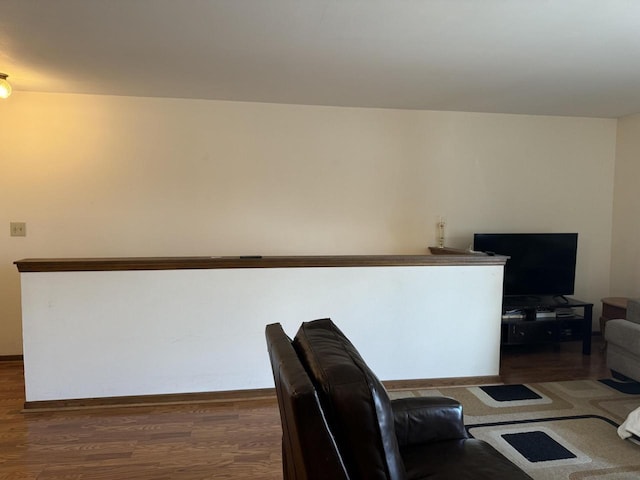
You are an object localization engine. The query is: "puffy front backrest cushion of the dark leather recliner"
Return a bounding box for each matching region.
[293,319,406,480]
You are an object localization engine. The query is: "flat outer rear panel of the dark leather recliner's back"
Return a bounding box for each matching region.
[265,323,349,480]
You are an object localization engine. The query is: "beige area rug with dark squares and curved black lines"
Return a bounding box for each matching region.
[390,380,640,480]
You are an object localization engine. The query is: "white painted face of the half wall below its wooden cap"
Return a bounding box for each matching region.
[21,265,503,402]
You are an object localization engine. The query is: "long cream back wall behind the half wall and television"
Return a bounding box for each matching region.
[0,92,616,355]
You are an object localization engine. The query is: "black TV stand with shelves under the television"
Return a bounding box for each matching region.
[501,296,593,355]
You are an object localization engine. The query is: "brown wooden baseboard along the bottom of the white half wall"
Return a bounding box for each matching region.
[23,376,502,412]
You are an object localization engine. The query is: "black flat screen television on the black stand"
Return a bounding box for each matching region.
[473,233,578,296]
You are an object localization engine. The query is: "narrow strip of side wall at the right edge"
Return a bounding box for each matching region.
[611,115,640,298]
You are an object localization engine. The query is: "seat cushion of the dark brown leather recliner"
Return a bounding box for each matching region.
[400,438,531,480]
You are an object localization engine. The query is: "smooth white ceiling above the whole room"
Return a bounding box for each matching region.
[0,0,640,117]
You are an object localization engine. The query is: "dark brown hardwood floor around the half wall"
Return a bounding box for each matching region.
[0,337,608,480]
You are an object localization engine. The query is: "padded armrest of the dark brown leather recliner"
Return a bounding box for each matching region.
[391,397,468,447]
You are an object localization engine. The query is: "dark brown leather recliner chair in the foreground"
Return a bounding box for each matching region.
[266,319,531,480]
